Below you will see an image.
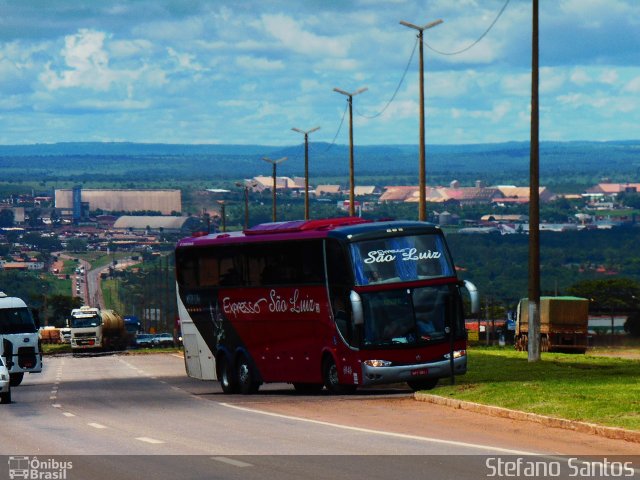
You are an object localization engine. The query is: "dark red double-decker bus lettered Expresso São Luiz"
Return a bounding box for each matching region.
[175,217,478,394]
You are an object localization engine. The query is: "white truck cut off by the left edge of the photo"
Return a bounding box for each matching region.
[0,292,42,386]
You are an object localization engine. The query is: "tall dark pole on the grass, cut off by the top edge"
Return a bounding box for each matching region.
[527,0,540,362]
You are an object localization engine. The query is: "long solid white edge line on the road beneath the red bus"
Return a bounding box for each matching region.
[220,402,540,455]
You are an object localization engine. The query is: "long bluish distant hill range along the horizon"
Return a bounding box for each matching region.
[0,140,640,185]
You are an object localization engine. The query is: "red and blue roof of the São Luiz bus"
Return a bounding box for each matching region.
[177,217,440,248]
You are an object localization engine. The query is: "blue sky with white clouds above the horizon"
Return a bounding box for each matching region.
[0,0,640,146]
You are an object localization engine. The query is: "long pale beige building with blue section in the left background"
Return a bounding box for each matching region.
[55,188,182,215]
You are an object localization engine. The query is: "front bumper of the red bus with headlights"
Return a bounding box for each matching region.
[362,352,467,385]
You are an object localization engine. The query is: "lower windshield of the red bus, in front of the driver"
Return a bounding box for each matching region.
[361,285,464,347]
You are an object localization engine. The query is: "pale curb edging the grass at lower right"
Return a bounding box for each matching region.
[414,392,640,443]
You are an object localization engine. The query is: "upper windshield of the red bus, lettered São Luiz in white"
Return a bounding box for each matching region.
[351,235,454,285]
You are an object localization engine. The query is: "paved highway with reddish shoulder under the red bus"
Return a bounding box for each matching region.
[0,354,638,479]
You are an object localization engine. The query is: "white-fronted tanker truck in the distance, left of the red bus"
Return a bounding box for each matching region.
[69,306,128,352]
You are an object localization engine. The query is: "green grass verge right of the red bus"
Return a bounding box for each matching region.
[436,348,640,430]
